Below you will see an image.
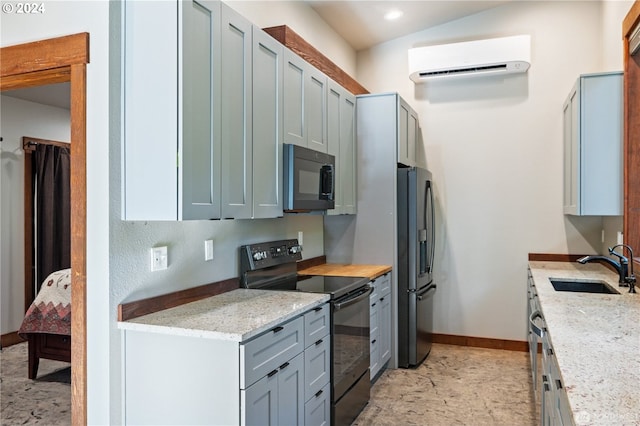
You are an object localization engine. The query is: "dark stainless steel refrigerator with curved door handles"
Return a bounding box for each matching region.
[397,167,436,367]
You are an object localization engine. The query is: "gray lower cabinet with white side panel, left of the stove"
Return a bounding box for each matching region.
[123,304,331,425]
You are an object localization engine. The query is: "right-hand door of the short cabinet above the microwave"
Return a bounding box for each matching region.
[304,63,327,152]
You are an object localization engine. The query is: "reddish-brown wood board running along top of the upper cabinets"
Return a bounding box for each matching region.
[263,25,369,95]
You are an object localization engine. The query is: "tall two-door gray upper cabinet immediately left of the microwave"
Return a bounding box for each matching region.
[221,4,284,219]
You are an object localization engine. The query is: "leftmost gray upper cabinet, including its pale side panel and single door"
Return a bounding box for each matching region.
[121,0,220,220]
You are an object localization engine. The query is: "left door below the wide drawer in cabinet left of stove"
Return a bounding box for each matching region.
[240,373,279,426]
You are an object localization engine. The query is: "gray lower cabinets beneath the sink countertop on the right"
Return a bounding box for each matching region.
[527,270,575,426]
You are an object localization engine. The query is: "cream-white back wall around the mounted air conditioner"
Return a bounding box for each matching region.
[357,1,630,341]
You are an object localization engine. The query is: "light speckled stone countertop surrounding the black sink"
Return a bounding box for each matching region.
[529,261,640,425]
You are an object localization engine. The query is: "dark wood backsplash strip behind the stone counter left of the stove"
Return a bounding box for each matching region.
[118,278,240,321]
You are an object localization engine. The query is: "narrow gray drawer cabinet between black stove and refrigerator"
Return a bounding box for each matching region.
[369,273,391,380]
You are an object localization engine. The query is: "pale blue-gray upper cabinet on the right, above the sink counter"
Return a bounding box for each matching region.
[563,72,623,216]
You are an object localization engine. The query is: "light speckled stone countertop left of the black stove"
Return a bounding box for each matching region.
[118,289,329,342]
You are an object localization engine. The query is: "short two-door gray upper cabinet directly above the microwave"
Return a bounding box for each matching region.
[284,49,328,152]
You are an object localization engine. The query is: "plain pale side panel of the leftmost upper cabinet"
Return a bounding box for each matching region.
[122,1,179,220]
